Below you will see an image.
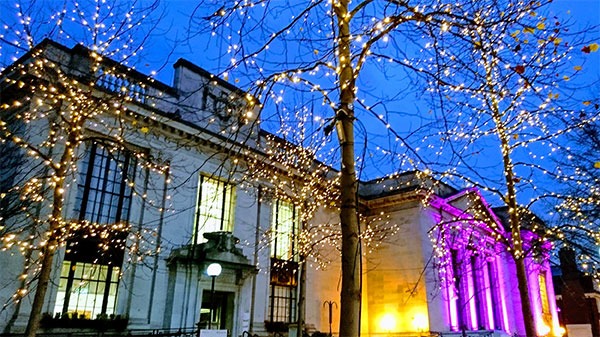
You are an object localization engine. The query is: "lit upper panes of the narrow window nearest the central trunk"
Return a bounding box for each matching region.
[271,200,299,261]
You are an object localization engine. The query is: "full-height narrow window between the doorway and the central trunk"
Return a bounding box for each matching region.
[269,200,300,323]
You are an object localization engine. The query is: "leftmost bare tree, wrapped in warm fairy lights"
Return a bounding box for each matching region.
[0,1,168,336]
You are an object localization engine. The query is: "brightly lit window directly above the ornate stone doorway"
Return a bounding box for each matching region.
[193,175,235,244]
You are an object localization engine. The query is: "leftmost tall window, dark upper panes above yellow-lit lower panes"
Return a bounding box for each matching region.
[54,143,136,318]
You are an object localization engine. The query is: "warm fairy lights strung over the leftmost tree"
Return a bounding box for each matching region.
[0,2,175,302]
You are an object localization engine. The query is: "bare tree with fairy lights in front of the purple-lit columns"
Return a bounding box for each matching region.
[410,3,599,336]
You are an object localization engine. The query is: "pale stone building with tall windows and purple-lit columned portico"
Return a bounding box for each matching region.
[0,41,560,336]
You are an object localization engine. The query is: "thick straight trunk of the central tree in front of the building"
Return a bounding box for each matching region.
[334,0,361,337]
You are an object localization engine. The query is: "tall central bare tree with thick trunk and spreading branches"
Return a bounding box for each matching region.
[185,0,588,337]
